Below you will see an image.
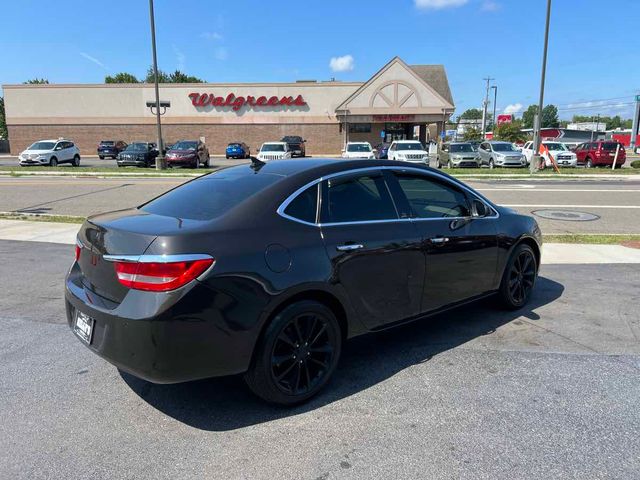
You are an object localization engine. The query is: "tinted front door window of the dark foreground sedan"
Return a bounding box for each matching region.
[396,174,470,218]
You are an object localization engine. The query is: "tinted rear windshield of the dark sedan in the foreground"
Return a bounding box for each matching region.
[140,166,281,220]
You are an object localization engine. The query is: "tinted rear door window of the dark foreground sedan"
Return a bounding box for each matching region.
[323,175,398,223]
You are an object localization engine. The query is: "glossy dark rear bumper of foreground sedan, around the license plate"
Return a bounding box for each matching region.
[65,265,252,383]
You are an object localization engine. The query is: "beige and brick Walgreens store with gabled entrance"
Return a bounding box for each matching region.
[3,57,454,155]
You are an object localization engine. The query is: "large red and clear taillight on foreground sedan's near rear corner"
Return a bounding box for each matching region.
[114,258,214,292]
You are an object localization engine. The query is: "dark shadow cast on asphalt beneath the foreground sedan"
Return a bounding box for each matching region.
[120,276,564,431]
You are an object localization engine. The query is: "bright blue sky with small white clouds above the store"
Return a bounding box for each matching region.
[0,0,640,118]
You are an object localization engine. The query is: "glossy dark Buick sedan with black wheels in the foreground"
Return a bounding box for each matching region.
[65,159,541,405]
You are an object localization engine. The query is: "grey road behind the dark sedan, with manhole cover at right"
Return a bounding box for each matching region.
[0,177,640,234]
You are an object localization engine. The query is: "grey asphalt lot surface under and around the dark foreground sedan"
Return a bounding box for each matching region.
[0,241,640,479]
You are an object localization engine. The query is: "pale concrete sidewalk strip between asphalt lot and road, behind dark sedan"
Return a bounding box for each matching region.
[0,220,640,265]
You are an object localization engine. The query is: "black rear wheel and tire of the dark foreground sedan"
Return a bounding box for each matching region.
[244,300,342,405]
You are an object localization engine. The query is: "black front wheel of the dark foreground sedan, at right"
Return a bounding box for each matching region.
[500,244,538,309]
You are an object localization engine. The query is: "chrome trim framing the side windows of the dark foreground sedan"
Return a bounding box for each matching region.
[276,165,500,227]
